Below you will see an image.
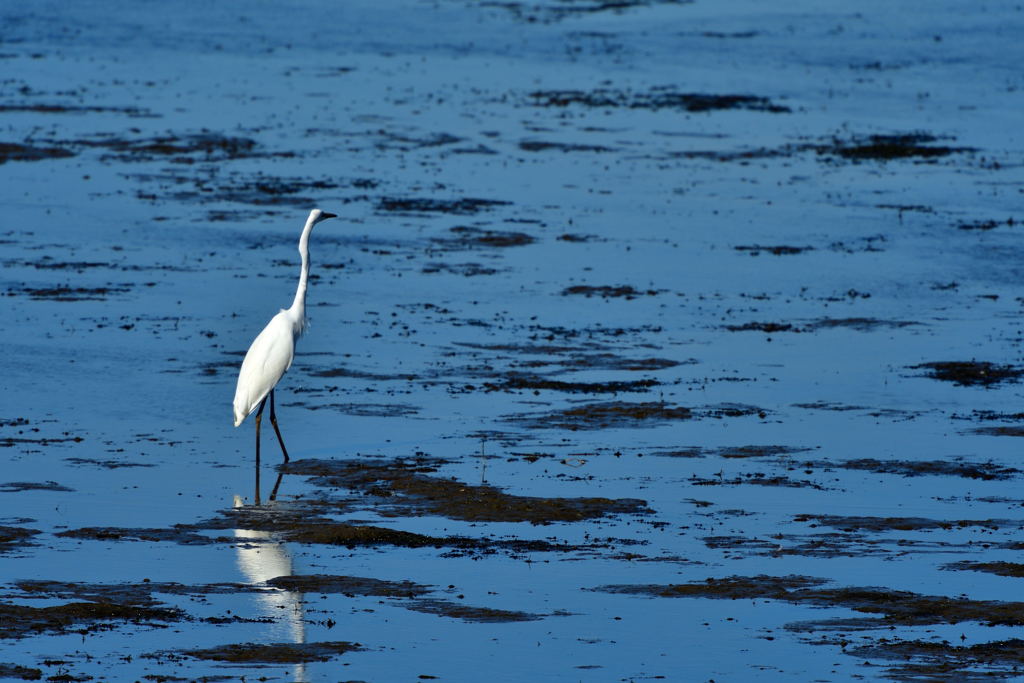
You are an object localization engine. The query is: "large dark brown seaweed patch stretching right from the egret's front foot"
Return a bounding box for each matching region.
[283,459,649,524]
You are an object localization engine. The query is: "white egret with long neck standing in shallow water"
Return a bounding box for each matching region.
[234,209,336,481]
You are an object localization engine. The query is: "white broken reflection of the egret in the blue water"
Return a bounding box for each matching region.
[234,496,306,681]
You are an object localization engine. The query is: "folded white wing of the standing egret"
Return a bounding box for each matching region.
[234,311,295,427]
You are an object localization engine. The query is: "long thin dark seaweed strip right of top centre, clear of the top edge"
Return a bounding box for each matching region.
[528,86,791,114]
